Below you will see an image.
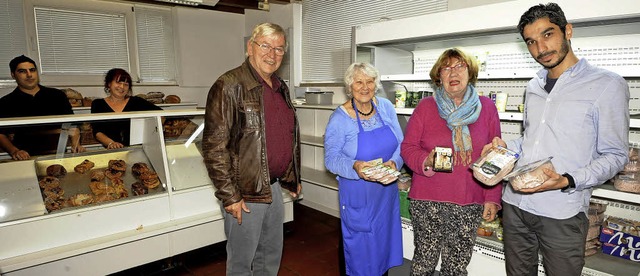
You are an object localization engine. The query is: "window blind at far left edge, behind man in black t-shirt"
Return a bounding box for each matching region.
[0,0,27,81]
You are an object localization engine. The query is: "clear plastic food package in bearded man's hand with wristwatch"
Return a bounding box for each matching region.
[505,157,555,191]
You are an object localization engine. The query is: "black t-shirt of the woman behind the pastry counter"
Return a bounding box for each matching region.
[91,96,162,146]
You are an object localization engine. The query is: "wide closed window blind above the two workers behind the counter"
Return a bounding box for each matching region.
[35,7,130,75]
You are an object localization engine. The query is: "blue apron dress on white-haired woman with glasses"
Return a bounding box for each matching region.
[338,102,403,276]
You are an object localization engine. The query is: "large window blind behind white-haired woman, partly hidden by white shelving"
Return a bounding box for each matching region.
[302,0,448,82]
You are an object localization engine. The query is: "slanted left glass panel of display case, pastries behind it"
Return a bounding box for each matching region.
[0,117,167,222]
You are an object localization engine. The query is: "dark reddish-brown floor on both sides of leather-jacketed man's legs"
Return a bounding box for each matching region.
[113,204,342,276]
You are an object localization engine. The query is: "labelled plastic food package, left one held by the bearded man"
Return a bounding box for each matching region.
[471,146,519,186]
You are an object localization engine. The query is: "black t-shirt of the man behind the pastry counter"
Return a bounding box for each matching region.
[0,86,73,155]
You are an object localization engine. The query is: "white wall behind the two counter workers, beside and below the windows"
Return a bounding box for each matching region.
[0,1,245,106]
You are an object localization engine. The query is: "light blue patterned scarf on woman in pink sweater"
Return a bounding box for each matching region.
[435,85,482,166]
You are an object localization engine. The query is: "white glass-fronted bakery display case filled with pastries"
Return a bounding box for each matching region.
[0,108,293,275]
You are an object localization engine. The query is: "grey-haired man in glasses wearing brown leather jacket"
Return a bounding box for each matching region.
[202,23,301,275]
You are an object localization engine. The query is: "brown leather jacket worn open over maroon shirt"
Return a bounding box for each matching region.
[202,60,300,207]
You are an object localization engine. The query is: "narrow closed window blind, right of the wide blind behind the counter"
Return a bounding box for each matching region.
[135,8,176,82]
